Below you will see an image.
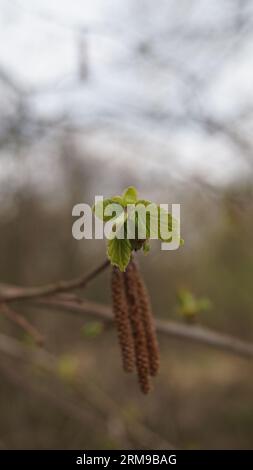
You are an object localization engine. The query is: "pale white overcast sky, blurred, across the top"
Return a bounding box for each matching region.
[0,0,253,184]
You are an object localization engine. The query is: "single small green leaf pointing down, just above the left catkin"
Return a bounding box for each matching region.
[107,237,132,271]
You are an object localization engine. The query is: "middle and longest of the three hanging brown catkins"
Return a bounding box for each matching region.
[124,261,150,393]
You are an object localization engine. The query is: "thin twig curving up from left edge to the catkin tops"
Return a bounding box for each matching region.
[0,260,110,302]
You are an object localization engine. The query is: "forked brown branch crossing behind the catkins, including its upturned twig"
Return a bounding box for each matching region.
[0,260,253,358]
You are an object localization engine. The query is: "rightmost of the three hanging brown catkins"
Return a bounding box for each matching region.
[133,262,160,376]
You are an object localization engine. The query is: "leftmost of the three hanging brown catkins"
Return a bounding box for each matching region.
[111,267,135,372]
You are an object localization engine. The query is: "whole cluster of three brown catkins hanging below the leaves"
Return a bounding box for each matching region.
[112,259,159,393]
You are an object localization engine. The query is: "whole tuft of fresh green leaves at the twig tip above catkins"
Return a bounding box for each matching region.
[93,186,184,260]
